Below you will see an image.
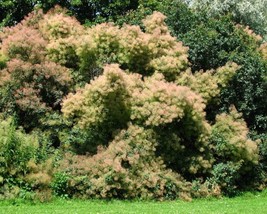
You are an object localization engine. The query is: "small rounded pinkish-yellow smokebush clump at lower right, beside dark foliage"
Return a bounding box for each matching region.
[211,109,258,164]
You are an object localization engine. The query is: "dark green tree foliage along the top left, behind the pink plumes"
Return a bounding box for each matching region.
[0,0,141,26]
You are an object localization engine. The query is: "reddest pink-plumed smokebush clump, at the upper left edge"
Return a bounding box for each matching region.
[0,8,72,131]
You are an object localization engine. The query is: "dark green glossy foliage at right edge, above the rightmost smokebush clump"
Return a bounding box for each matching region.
[221,53,267,134]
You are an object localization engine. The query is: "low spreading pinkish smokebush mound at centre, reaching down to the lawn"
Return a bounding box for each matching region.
[55,125,219,200]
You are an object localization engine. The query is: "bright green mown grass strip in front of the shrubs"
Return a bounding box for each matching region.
[0,191,267,214]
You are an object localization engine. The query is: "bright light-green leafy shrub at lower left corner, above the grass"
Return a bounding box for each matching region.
[0,118,53,200]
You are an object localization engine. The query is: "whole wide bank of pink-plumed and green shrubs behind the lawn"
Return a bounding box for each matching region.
[0,5,266,200]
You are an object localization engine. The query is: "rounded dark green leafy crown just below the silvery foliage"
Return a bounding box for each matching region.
[180,16,257,71]
